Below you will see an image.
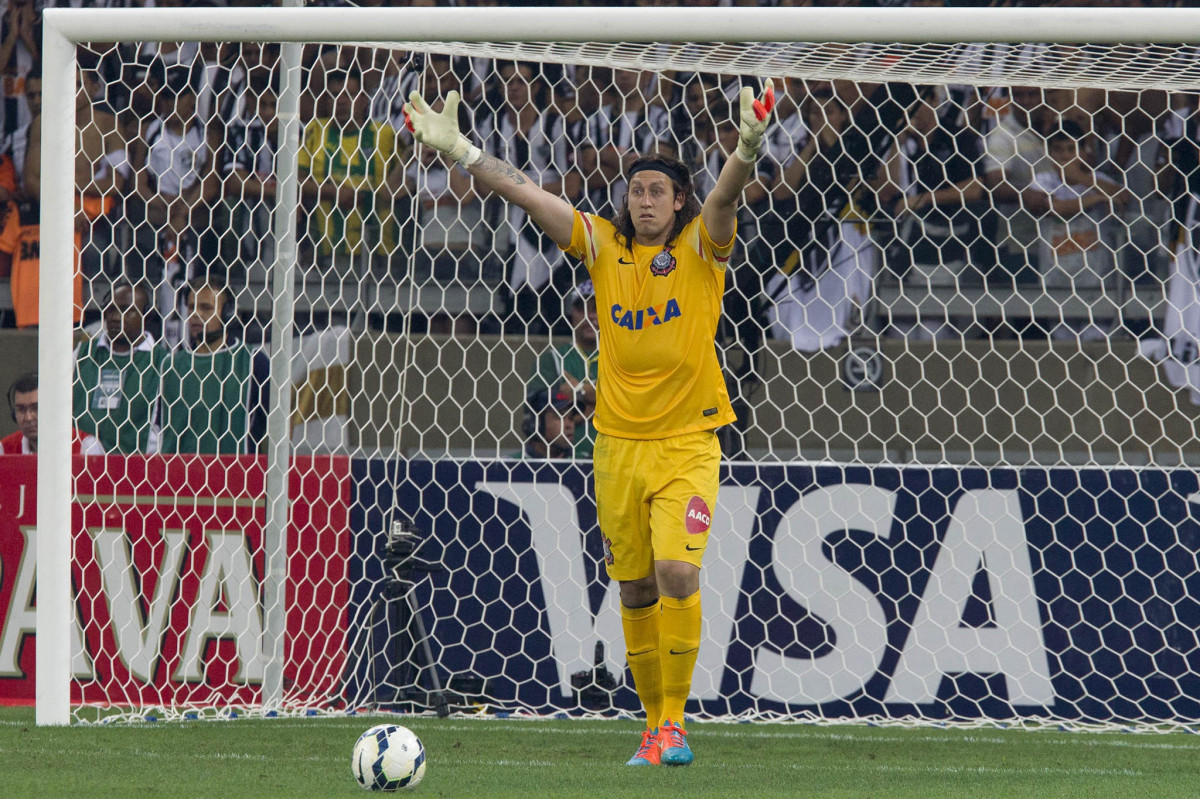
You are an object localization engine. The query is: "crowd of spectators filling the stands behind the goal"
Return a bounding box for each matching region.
[0,0,1198,352]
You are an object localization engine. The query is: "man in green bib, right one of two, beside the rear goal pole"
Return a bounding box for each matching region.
[160,277,270,455]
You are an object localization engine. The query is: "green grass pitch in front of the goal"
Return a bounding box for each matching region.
[0,708,1200,799]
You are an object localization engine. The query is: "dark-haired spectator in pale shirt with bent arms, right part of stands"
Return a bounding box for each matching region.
[1034,120,1127,341]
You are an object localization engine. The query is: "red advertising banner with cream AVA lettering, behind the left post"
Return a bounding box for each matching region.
[0,456,350,707]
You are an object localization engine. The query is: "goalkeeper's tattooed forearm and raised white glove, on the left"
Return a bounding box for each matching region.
[404,91,575,248]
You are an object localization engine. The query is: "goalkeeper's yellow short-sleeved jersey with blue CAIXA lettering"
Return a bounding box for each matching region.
[566,211,737,439]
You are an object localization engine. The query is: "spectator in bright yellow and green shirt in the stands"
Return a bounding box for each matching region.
[299,68,403,269]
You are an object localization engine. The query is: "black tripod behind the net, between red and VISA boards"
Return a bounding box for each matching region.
[343,518,450,719]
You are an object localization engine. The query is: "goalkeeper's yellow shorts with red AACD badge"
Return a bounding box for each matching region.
[593,431,721,581]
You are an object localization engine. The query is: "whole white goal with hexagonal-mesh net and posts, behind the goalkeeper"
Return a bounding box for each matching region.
[23,10,1200,728]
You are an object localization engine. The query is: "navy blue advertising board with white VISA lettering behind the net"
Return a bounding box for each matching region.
[350,453,1200,721]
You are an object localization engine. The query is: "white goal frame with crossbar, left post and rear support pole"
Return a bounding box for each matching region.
[36,7,1200,725]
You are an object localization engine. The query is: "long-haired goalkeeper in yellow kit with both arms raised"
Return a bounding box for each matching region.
[404,80,775,765]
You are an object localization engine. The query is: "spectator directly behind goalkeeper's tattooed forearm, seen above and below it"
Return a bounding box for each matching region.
[478,61,566,335]
